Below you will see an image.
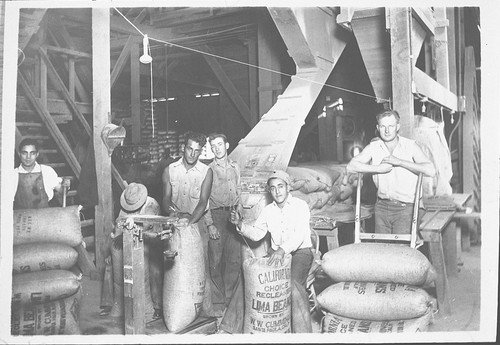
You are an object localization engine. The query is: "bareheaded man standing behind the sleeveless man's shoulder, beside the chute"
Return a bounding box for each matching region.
[208,133,241,307]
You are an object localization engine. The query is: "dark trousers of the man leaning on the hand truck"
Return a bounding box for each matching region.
[375,198,424,234]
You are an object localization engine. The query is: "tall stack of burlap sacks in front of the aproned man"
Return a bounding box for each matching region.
[11,206,83,335]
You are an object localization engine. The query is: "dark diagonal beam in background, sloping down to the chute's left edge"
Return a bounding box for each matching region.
[203,46,257,128]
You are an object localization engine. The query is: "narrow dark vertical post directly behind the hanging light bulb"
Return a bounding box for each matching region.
[130,43,141,144]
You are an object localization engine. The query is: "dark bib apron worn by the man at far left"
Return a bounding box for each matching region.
[14,172,49,210]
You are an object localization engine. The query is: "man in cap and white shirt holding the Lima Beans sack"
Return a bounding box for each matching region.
[220,170,313,333]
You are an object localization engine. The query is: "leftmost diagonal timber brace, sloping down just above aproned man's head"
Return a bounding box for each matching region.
[18,73,81,178]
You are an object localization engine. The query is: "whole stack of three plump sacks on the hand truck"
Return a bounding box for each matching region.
[317,243,436,333]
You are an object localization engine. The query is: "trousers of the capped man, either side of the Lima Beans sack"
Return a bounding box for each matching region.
[219,248,314,334]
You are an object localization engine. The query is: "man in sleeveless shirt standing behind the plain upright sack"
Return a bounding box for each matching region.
[162,132,215,316]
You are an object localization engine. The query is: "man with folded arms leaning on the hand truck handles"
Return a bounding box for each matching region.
[347,110,436,234]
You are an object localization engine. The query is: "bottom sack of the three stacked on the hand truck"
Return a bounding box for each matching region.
[321,309,433,333]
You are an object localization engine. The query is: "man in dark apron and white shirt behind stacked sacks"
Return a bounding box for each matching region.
[14,138,70,210]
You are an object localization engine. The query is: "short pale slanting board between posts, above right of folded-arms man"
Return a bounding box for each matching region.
[413,68,458,111]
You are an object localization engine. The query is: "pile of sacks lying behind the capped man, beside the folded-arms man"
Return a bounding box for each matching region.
[286,161,357,213]
